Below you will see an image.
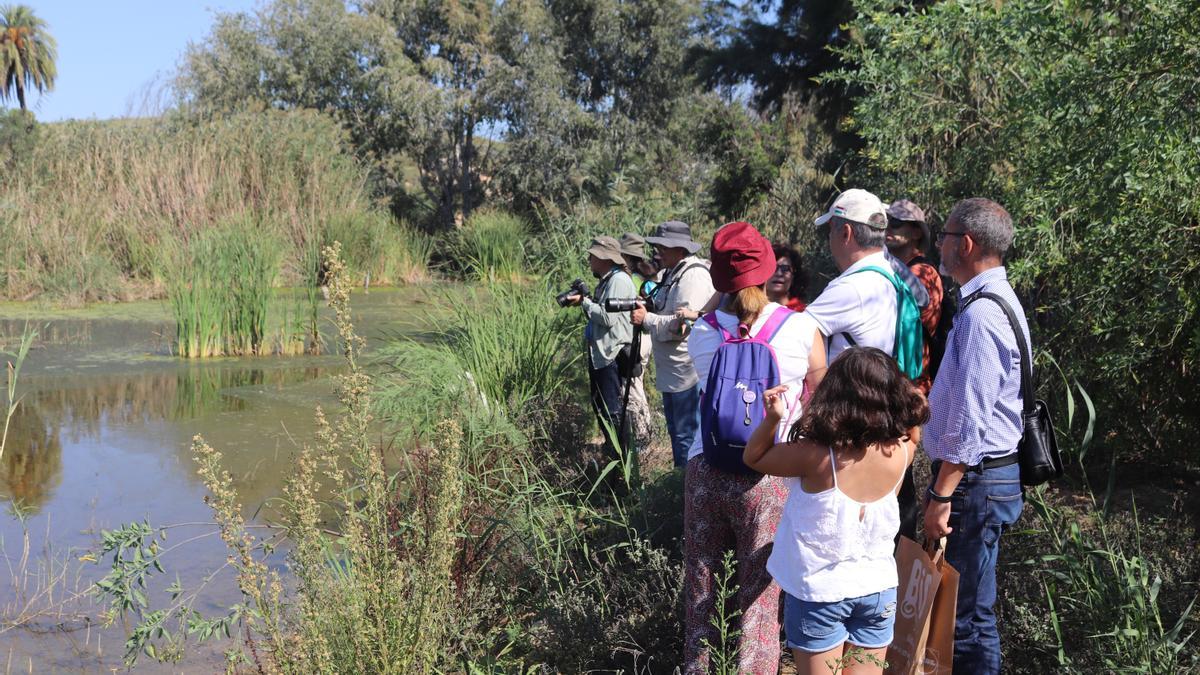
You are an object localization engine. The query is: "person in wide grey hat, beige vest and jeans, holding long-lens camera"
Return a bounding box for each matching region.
[632,220,716,466]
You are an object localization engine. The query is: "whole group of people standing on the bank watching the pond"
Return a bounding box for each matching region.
[571,190,1028,674]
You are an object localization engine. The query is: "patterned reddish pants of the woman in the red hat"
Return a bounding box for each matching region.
[684,456,787,675]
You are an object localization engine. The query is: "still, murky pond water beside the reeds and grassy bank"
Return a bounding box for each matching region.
[0,289,441,673]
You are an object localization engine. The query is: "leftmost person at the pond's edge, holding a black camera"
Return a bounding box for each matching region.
[565,237,637,455]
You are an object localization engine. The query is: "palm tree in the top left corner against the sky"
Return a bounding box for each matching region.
[0,5,58,110]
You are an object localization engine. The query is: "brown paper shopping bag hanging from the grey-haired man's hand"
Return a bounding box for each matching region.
[887,537,959,675]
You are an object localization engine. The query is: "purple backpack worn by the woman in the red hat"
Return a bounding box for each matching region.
[700,307,796,473]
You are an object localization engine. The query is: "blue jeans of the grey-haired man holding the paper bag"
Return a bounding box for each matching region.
[935,464,1024,675]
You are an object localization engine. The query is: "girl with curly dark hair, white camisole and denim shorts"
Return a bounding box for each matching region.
[744,347,929,675]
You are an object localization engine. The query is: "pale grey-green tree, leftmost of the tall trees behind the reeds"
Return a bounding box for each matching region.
[175,0,416,210]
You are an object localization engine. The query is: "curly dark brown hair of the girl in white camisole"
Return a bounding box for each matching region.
[788,347,929,448]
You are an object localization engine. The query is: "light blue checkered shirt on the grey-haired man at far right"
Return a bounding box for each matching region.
[924,267,1033,466]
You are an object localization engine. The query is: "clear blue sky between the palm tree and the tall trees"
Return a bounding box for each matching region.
[14,0,258,121]
